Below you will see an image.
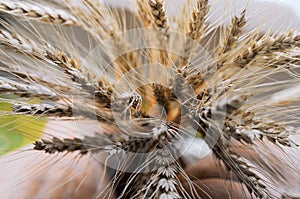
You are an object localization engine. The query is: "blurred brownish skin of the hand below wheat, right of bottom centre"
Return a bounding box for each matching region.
[179,155,253,199]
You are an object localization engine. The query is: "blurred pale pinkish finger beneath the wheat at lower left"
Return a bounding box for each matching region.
[22,154,114,199]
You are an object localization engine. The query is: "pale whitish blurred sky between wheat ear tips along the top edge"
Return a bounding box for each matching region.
[100,0,300,29]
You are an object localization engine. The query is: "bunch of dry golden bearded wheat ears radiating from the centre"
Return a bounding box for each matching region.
[0,0,300,199]
